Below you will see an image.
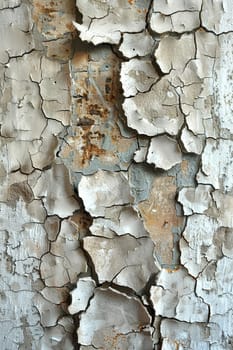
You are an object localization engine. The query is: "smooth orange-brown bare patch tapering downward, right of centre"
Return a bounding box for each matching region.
[139,176,183,264]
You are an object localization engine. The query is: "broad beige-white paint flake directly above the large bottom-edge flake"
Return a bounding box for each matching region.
[84,235,158,292]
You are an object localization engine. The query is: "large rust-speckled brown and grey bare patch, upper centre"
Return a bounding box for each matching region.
[61,50,137,170]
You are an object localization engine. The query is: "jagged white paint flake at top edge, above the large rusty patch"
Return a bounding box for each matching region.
[74,0,149,45]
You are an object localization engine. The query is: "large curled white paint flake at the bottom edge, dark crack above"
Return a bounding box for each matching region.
[78,288,152,350]
